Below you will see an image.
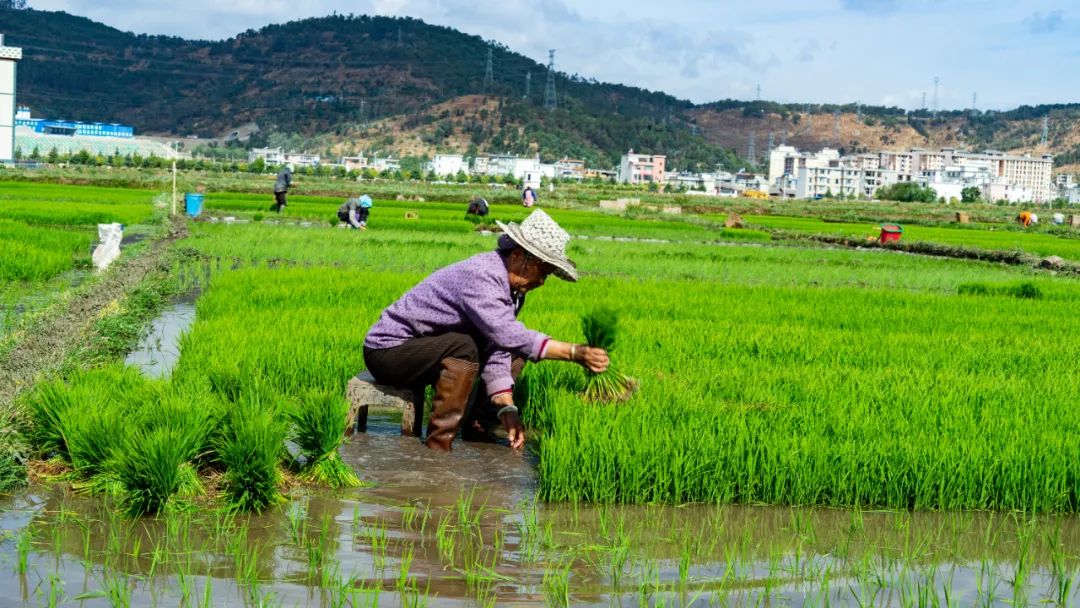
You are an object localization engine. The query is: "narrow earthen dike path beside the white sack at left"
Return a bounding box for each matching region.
[0,215,188,413]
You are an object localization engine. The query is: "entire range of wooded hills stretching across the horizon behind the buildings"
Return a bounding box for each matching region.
[0,9,1080,170]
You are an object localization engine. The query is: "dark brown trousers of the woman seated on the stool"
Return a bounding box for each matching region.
[364,332,525,425]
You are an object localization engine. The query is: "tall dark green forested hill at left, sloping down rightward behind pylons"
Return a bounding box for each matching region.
[0,10,738,171]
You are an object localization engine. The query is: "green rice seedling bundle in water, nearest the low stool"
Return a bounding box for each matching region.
[289,391,362,488]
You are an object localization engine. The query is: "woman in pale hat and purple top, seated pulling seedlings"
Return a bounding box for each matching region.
[364,211,608,451]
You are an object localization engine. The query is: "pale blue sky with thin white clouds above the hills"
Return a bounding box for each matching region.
[30,0,1080,109]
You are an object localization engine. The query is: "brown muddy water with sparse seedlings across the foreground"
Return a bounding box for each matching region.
[0,414,1080,606]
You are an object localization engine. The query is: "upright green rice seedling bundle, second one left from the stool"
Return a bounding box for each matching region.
[215,396,288,511]
